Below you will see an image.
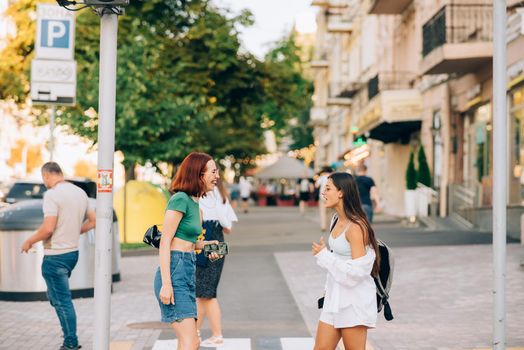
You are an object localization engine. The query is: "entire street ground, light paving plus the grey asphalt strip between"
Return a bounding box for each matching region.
[0,208,524,350]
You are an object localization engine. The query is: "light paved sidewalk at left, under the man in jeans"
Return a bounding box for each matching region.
[0,256,161,350]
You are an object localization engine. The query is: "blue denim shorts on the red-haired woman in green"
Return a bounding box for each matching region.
[154,250,197,323]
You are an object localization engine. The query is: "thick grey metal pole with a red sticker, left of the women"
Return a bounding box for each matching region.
[93,9,118,350]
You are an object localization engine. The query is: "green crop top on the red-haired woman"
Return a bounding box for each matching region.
[166,192,202,243]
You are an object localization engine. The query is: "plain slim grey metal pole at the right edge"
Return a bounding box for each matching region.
[493,0,508,350]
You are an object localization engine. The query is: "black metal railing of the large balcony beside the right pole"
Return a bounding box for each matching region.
[422,3,493,56]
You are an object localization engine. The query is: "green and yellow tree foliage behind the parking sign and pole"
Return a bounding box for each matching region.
[0,0,312,171]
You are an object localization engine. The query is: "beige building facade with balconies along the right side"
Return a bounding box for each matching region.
[311,0,524,237]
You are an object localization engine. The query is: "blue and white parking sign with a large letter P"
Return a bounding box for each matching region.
[35,4,75,60]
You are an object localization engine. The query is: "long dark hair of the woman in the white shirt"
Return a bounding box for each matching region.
[328,172,380,276]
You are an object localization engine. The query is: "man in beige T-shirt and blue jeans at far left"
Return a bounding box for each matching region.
[22,162,96,350]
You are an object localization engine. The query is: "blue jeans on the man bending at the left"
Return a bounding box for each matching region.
[42,251,78,348]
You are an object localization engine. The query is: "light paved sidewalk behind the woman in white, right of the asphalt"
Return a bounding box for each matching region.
[275,244,524,350]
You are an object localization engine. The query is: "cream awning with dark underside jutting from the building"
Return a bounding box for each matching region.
[357,90,422,143]
